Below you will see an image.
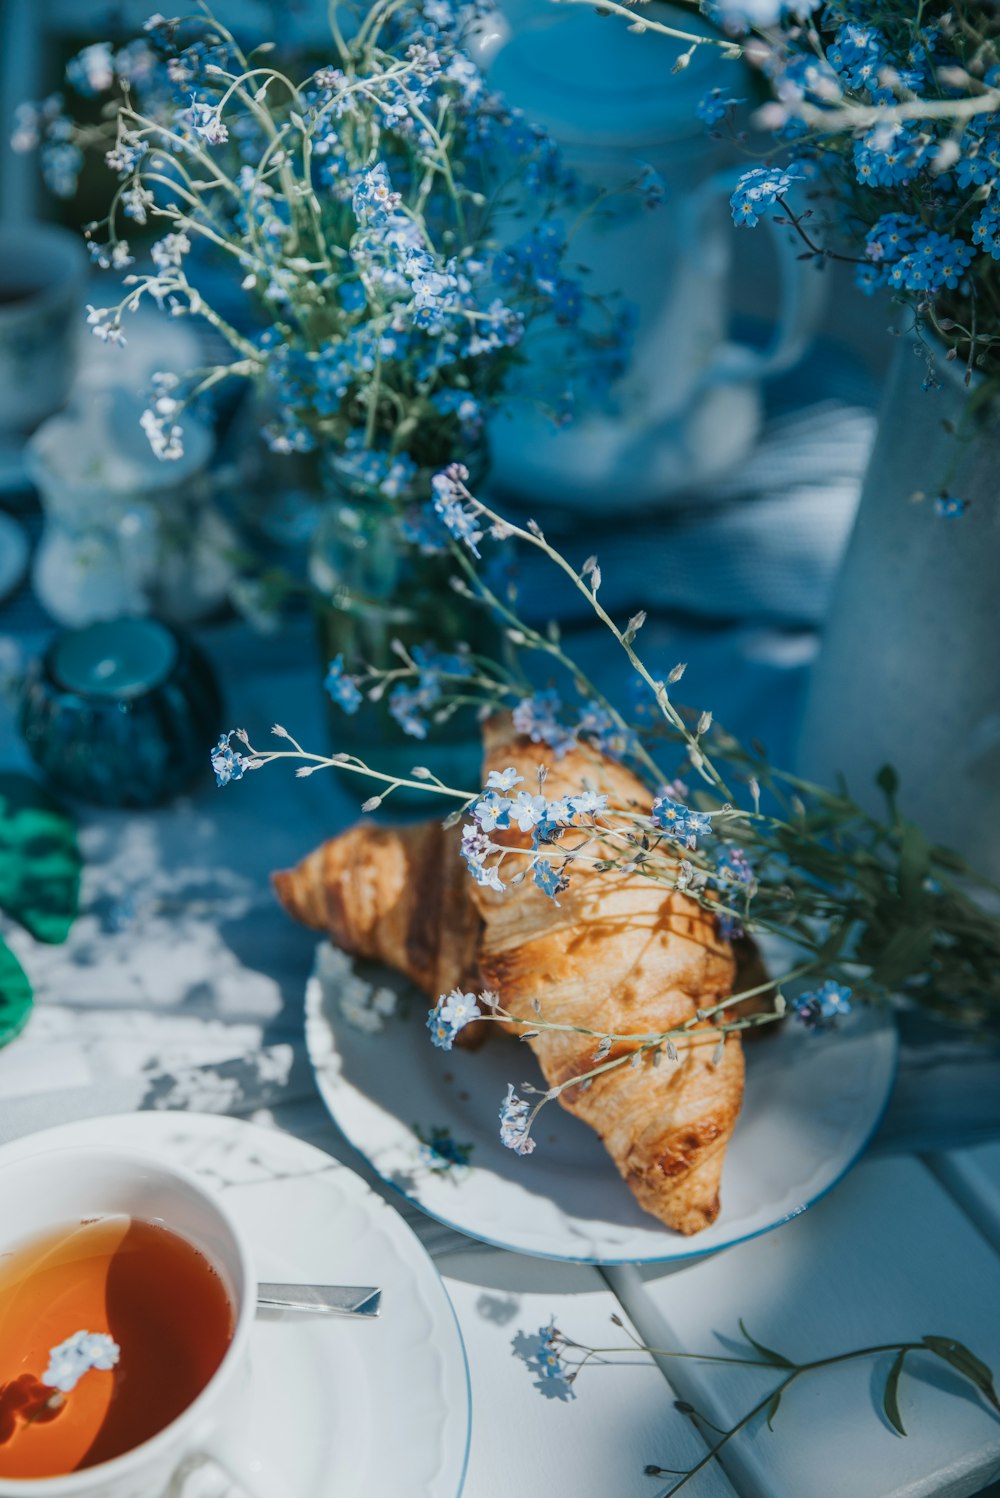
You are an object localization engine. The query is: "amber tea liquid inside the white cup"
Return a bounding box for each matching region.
[0,1216,235,1479]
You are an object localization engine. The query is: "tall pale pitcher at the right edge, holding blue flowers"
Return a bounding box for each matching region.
[796,334,1000,882]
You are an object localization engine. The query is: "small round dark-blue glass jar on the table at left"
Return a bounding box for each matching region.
[21,617,223,807]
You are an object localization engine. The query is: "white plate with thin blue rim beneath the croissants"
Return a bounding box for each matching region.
[305,944,898,1264]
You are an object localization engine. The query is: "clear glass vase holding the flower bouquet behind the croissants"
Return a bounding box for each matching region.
[308,457,496,816]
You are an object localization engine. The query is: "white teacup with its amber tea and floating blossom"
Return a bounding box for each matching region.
[0,1149,256,1498]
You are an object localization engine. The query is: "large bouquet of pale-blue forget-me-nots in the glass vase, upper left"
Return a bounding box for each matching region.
[13,0,637,476]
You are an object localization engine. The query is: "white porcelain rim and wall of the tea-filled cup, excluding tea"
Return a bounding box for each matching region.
[0,1147,263,1498]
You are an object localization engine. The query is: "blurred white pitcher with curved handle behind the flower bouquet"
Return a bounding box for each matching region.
[490,0,823,511]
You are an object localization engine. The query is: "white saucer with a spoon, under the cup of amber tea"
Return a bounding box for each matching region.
[0,1113,470,1498]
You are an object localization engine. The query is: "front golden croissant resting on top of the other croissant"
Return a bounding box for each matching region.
[472,718,744,1233]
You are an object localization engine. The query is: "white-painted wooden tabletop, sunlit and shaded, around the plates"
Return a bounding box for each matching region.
[0,616,1000,1498]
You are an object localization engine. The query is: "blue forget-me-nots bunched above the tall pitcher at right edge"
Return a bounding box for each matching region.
[715,0,1000,398]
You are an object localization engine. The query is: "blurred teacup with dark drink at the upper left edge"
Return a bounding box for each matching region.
[0,223,88,434]
